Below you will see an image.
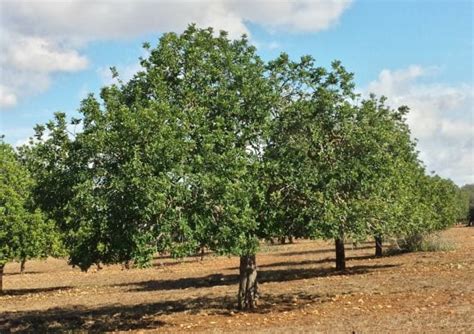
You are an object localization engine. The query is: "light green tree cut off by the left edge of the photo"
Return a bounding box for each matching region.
[0,139,58,292]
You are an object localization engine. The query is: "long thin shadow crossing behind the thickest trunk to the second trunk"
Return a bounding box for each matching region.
[115,264,398,291]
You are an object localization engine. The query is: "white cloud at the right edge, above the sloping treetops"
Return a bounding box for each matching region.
[366,65,474,185]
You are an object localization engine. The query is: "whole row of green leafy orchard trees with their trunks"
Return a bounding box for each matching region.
[0,26,461,308]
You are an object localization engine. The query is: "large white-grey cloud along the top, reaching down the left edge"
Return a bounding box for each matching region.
[0,0,352,107]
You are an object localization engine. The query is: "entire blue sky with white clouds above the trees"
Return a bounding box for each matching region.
[0,0,474,185]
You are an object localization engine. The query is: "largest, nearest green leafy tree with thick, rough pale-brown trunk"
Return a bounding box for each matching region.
[29,26,272,308]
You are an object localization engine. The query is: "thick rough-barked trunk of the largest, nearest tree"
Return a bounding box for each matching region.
[238,255,258,310]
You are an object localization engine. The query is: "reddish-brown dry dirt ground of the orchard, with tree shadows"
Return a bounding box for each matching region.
[0,227,474,333]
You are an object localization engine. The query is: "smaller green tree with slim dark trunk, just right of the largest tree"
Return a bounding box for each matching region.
[265,54,418,270]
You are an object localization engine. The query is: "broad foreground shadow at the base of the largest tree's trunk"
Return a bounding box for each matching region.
[0,293,332,333]
